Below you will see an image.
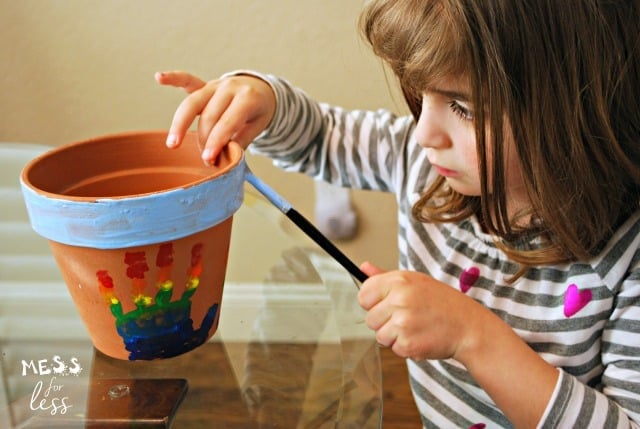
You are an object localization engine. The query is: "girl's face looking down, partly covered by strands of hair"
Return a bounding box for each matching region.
[415,79,527,211]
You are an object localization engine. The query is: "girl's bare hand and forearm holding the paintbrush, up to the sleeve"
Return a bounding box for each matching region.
[358,263,559,427]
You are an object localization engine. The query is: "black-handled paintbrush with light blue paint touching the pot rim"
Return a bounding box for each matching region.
[245,167,368,283]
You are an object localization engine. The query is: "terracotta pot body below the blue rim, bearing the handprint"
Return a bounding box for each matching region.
[50,218,232,360]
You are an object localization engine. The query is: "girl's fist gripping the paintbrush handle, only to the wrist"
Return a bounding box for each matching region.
[358,263,496,363]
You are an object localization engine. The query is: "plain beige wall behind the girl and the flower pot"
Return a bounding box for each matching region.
[0,0,402,266]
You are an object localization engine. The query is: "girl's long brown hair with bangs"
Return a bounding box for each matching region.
[361,0,640,268]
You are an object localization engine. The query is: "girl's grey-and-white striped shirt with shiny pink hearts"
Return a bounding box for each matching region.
[252,75,640,428]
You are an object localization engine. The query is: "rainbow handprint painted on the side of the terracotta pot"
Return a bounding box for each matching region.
[96,243,219,360]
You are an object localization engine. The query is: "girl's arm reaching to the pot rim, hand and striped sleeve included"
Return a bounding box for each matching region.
[155,71,414,191]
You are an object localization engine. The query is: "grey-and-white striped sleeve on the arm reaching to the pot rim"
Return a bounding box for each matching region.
[235,72,414,192]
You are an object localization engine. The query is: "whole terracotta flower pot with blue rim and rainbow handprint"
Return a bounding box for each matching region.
[21,132,246,360]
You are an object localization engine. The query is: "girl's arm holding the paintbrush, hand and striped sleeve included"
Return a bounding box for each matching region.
[358,256,640,429]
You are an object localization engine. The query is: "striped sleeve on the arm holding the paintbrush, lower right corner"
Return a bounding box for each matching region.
[539,260,640,429]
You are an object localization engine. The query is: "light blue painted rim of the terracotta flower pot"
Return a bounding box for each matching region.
[20,155,247,249]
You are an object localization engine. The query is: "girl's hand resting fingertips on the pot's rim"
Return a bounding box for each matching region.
[155,71,276,164]
